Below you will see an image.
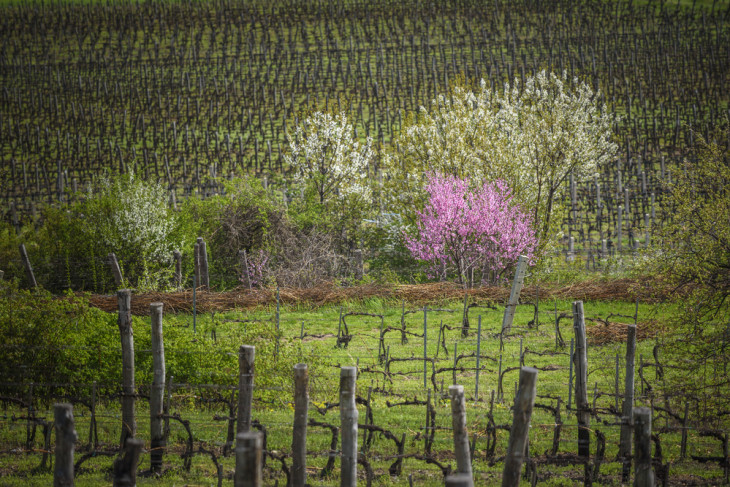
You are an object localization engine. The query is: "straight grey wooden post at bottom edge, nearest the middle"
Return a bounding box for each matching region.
[340,367,358,487]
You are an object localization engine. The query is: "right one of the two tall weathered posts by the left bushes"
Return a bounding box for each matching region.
[150,303,165,472]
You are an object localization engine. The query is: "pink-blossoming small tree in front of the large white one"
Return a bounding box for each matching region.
[405,173,537,285]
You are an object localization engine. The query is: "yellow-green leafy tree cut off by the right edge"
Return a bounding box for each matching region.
[647,126,730,420]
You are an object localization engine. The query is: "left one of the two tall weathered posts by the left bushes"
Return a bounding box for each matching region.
[117,289,137,448]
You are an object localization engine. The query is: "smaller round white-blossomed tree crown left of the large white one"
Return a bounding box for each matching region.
[285,112,374,203]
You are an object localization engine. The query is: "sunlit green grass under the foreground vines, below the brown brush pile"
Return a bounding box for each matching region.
[0,299,722,486]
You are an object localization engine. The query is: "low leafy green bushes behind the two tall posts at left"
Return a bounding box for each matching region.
[0,281,322,399]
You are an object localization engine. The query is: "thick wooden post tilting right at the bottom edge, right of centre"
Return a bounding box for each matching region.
[502,367,537,487]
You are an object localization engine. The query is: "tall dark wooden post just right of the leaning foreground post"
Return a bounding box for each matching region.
[573,301,591,458]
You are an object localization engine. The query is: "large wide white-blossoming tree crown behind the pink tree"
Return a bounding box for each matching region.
[385,71,618,247]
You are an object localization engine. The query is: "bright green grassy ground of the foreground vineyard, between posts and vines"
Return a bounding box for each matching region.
[0,292,722,486]
